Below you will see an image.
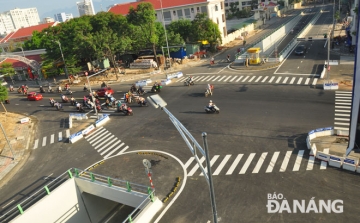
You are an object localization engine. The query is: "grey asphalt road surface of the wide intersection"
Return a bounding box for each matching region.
[0,4,359,222]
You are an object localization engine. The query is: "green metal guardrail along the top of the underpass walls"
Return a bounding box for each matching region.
[0,168,155,222]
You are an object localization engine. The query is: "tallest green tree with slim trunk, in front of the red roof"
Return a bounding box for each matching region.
[127,2,159,63]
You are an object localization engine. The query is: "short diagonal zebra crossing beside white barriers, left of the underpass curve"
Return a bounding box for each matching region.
[85,127,129,159]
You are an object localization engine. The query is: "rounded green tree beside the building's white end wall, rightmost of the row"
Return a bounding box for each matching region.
[191,13,222,50]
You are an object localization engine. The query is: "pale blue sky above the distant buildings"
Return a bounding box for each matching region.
[0,0,129,20]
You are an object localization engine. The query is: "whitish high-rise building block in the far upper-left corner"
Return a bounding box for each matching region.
[0,8,40,34]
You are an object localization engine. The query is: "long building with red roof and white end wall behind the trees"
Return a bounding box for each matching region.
[108,0,227,41]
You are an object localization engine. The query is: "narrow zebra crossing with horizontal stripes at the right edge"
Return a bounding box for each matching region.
[334,91,352,131]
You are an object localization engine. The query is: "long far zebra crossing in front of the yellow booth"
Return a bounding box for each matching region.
[175,75,319,86]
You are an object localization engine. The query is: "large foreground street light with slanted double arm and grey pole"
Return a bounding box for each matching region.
[147,94,218,223]
